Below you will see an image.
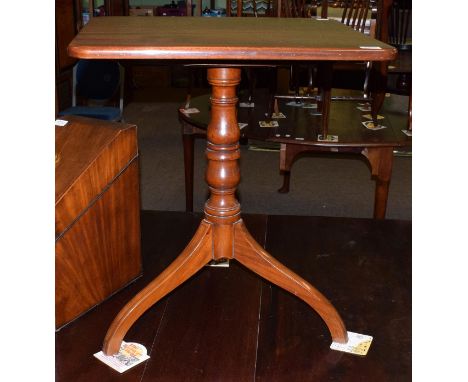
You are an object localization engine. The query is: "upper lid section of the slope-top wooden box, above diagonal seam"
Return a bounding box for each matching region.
[55,116,138,238]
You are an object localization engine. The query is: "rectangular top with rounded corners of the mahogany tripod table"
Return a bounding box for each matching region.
[68,16,396,62]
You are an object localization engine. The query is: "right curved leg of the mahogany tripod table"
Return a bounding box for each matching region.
[234,221,348,343]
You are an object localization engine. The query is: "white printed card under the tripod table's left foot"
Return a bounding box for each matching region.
[94,341,150,373]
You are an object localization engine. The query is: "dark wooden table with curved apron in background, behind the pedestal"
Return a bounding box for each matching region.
[179,89,411,219]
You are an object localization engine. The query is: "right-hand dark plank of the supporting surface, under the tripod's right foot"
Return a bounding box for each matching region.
[256,216,411,381]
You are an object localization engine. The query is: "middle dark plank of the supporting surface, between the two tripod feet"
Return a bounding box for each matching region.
[143,216,266,382]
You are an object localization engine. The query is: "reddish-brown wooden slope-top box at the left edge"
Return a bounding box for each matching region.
[55,116,141,328]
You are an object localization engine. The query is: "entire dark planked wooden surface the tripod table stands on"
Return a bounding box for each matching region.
[56,211,411,382]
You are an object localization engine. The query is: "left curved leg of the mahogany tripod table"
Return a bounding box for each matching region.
[102,220,212,355]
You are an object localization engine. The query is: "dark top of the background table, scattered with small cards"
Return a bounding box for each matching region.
[178,89,411,147]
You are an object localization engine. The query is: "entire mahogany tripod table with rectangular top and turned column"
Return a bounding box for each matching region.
[68,17,396,355]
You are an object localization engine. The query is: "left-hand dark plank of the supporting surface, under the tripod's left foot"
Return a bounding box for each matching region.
[55,211,202,382]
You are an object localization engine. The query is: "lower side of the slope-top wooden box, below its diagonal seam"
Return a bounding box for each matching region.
[55,160,141,327]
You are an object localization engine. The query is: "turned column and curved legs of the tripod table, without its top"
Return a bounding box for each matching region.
[103,67,347,355]
